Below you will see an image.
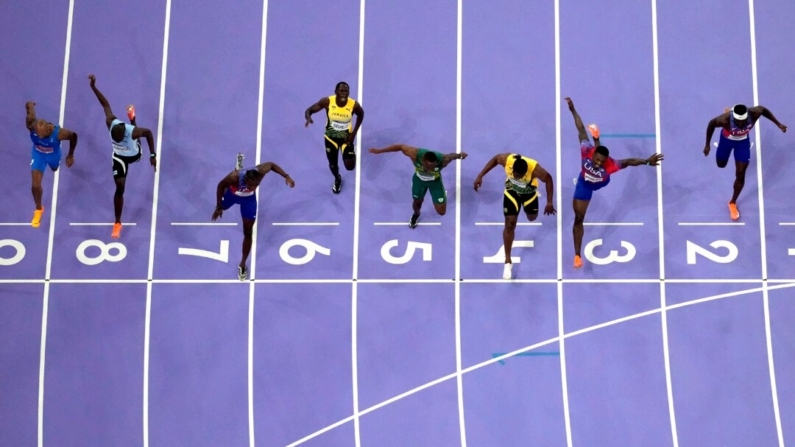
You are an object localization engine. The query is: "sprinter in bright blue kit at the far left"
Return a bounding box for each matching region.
[25,101,77,228]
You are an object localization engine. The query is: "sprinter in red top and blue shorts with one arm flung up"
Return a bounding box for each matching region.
[566,98,663,269]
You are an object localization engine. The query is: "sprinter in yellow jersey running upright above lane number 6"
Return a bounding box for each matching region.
[304,82,364,194]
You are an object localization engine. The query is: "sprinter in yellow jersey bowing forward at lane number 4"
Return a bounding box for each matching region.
[475,153,555,279]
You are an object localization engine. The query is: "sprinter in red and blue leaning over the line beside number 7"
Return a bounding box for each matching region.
[212,162,295,281]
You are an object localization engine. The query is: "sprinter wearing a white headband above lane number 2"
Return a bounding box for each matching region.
[704,104,787,224]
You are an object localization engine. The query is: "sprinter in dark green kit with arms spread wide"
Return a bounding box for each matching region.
[370,144,467,228]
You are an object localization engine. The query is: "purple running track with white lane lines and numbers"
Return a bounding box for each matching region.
[0,0,795,447]
